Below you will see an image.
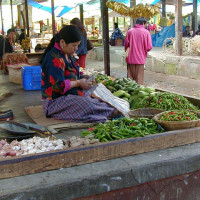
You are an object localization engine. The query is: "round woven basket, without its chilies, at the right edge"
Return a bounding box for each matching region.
[153,110,200,131]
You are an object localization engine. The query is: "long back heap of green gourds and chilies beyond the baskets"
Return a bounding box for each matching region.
[95,74,198,111]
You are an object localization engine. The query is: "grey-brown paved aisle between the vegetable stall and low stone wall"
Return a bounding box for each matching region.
[86,59,200,98]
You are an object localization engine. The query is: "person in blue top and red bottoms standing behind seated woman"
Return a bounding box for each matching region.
[70,18,88,69]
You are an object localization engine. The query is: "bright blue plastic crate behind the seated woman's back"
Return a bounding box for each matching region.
[22,66,41,90]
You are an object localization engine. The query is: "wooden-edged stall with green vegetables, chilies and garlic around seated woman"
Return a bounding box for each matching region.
[0,74,200,179]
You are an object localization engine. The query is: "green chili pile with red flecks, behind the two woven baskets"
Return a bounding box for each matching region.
[132,92,198,110]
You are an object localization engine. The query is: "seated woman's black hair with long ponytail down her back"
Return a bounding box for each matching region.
[40,25,82,63]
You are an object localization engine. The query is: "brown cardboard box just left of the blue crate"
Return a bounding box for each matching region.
[7,63,30,84]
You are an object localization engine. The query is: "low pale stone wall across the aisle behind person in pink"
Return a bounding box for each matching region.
[87,47,200,79]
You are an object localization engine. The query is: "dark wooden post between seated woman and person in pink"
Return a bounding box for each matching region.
[101,0,110,76]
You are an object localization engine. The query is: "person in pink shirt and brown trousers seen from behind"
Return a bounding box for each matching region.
[125,17,152,85]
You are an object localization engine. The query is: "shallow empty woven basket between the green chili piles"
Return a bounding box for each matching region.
[128,108,164,119]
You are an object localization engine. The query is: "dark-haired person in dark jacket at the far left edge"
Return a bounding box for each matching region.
[0,29,15,58]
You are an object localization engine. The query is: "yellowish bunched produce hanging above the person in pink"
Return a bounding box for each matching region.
[106,1,160,18]
